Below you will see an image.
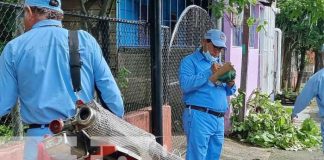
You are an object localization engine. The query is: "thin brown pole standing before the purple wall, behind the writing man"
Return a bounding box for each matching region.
[239,5,250,122]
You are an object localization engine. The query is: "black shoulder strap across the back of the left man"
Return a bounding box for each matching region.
[69,30,82,92]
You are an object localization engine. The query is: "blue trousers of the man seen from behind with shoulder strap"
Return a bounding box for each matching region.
[24,127,52,160]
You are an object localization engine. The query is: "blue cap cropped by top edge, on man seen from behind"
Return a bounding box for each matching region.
[25,0,63,13]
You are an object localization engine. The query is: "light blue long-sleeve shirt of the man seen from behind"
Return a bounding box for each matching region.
[0,20,124,124]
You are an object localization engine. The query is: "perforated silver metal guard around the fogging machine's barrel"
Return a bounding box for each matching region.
[84,101,181,160]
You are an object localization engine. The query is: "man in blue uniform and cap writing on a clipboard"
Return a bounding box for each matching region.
[179,29,236,160]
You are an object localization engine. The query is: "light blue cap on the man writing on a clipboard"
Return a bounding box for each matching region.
[204,29,227,48]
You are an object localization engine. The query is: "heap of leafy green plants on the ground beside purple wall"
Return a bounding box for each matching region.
[231,91,321,150]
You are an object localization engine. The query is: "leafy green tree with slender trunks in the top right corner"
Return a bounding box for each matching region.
[276,0,324,91]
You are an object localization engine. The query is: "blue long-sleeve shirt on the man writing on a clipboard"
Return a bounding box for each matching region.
[179,50,236,112]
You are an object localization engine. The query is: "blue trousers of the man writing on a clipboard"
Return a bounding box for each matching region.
[182,108,224,160]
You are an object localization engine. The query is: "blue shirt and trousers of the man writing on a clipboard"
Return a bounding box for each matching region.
[179,50,236,160]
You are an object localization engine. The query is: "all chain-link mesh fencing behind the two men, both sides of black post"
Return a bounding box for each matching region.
[0,2,213,154]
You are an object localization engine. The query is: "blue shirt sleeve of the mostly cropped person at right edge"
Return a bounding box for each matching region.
[292,68,324,118]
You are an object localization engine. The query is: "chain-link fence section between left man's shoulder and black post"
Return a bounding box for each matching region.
[63,13,155,112]
